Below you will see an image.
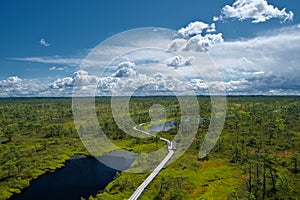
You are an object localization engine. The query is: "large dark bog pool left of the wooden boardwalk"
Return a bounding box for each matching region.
[11,157,132,200]
